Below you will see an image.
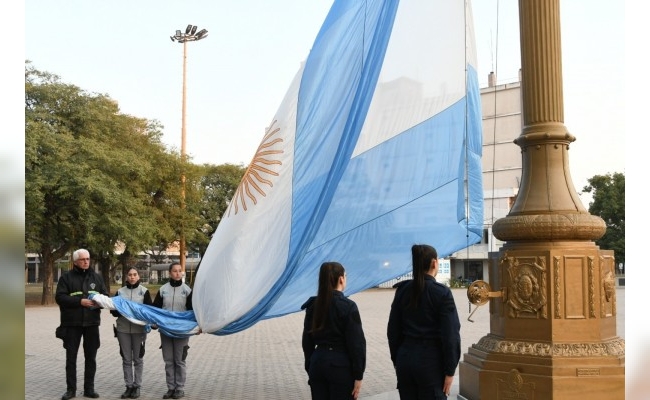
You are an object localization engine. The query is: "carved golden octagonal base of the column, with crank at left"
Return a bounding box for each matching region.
[458,242,625,400]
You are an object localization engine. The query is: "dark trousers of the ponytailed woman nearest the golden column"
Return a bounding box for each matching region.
[395,343,447,400]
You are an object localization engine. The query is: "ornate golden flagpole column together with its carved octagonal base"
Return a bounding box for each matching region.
[459,0,625,400]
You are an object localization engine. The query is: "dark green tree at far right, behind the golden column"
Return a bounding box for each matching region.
[582,172,625,263]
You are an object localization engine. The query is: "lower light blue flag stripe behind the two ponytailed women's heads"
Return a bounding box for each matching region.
[266,92,483,318]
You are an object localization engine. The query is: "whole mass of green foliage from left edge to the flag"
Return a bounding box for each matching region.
[25,62,246,304]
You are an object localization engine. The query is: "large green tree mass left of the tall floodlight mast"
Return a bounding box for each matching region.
[25,62,181,304]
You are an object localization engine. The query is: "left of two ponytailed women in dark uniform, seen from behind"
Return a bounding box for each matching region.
[302,262,366,400]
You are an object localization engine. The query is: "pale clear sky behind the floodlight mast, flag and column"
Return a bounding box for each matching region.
[25,0,625,200]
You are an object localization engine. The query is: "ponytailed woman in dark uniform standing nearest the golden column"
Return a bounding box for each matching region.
[387,244,460,400]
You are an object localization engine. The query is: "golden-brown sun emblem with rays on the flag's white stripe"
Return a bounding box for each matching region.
[228,120,284,216]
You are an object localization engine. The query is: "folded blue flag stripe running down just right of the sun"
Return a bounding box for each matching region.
[217,0,399,335]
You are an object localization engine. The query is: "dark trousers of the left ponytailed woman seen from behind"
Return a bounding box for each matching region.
[309,349,354,400]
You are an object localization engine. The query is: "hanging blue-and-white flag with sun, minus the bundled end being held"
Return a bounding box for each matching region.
[193,0,483,335]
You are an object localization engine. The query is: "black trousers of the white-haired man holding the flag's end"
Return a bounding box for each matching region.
[63,326,99,392]
